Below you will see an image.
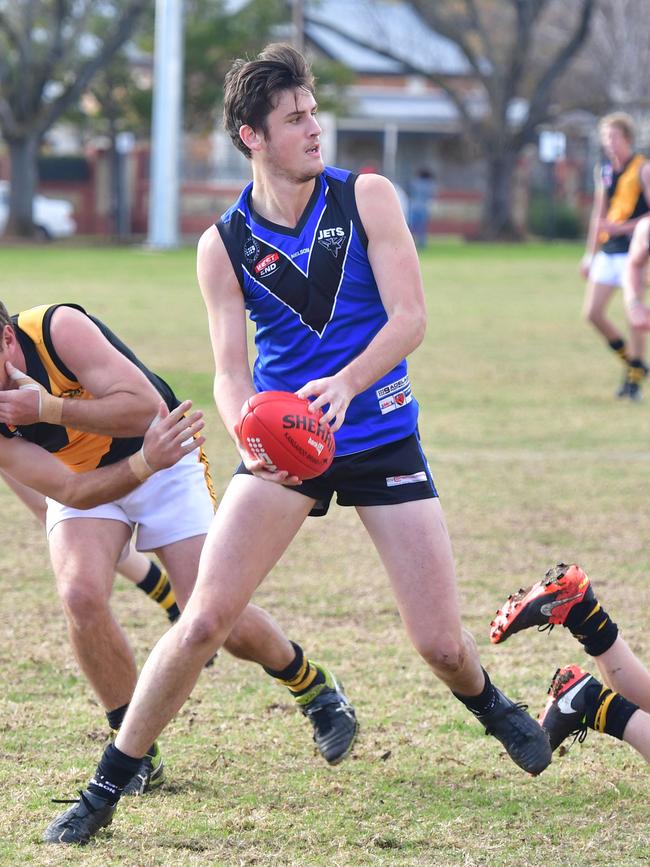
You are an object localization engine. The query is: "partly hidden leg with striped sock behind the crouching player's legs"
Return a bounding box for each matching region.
[0,470,181,623]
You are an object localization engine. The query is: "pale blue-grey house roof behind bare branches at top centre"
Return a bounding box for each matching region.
[305,0,470,75]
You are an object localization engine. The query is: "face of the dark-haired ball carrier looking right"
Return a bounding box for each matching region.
[256,88,324,183]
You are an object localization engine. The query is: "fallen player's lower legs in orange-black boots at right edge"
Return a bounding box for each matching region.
[490,563,650,762]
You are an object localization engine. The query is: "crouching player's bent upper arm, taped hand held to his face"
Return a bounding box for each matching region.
[0,307,160,437]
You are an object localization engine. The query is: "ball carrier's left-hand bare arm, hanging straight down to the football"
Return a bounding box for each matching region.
[196,226,299,484]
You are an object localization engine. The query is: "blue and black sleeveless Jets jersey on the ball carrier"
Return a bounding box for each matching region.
[216,167,418,456]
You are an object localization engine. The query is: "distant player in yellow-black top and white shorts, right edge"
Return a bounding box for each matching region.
[580,112,650,400]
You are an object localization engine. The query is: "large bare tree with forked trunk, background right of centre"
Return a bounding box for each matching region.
[308,0,597,237]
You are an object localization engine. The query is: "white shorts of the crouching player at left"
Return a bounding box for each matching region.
[45,452,215,559]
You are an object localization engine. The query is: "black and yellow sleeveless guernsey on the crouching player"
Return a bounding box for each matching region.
[0,304,179,472]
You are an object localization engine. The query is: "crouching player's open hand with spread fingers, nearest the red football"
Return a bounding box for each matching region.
[142,400,205,472]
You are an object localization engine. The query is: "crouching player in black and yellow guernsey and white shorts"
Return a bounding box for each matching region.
[0,304,356,808]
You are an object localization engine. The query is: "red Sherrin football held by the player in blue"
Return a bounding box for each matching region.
[239,391,335,479]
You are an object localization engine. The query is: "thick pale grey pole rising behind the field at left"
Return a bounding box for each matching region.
[148,0,183,249]
